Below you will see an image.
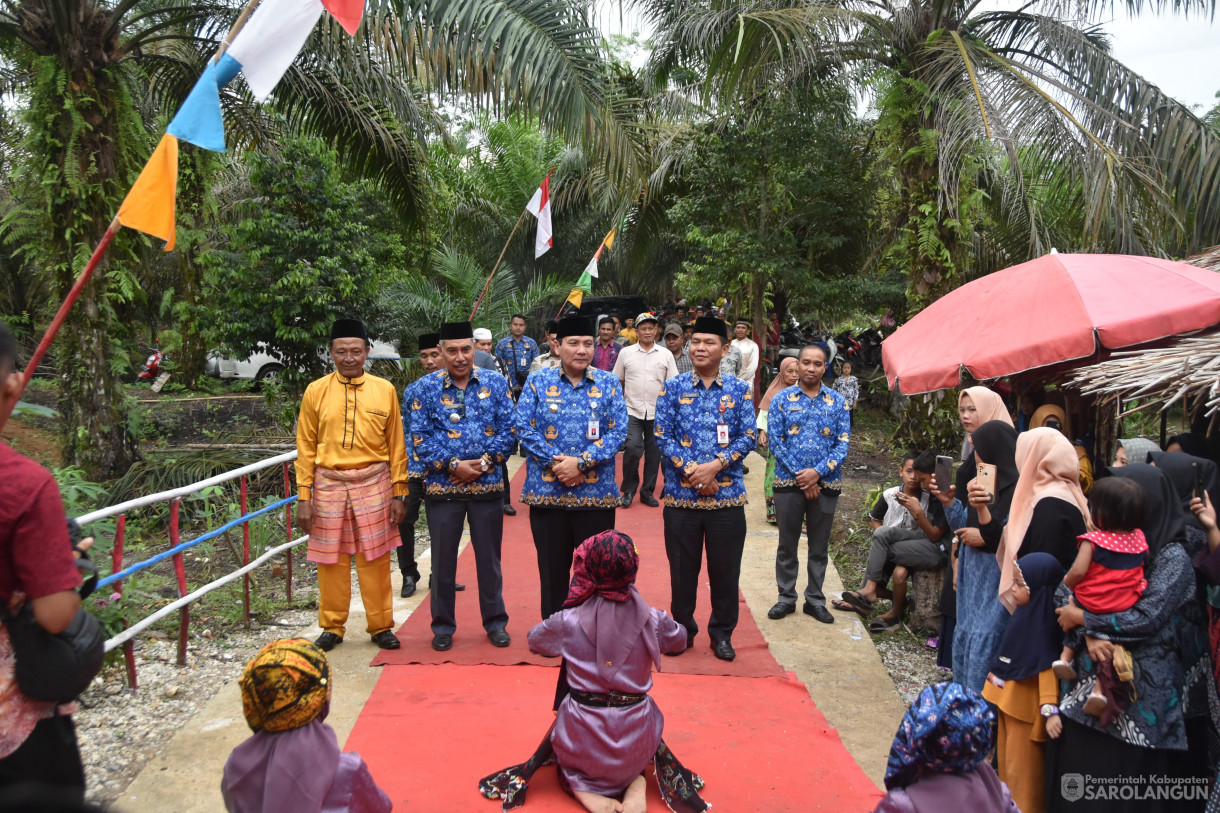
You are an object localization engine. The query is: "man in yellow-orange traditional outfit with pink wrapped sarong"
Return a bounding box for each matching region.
[296,319,407,652]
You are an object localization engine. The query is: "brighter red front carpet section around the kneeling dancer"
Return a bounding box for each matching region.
[345,658,881,813]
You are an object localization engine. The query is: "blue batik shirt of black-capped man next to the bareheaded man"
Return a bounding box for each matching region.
[654,371,755,509]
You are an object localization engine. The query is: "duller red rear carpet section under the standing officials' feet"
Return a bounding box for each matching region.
[372,457,783,678]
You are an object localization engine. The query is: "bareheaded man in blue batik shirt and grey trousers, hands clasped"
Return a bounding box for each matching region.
[766,344,852,624]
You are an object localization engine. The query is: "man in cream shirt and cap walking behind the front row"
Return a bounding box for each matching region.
[614,313,678,508]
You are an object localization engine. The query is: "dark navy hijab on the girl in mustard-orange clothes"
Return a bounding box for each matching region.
[992,553,1065,680]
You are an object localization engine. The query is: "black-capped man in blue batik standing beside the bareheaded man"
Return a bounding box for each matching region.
[654,317,754,660]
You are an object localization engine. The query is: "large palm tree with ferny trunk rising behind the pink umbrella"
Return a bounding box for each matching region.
[642,0,1220,305]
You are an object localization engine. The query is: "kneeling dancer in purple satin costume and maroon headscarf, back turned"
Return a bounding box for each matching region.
[478,531,710,813]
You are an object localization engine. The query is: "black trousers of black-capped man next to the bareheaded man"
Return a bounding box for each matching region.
[664,505,745,641]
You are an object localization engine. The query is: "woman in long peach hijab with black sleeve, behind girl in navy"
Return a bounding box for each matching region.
[997,427,1088,612]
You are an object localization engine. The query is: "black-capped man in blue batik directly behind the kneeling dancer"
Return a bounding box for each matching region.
[517,316,627,619]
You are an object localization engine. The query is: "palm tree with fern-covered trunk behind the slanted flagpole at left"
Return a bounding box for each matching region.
[0,0,644,477]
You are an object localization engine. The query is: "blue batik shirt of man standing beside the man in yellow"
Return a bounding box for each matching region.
[411,367,516,497]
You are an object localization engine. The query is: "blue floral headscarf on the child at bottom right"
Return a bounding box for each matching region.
[886,682,996,790]
